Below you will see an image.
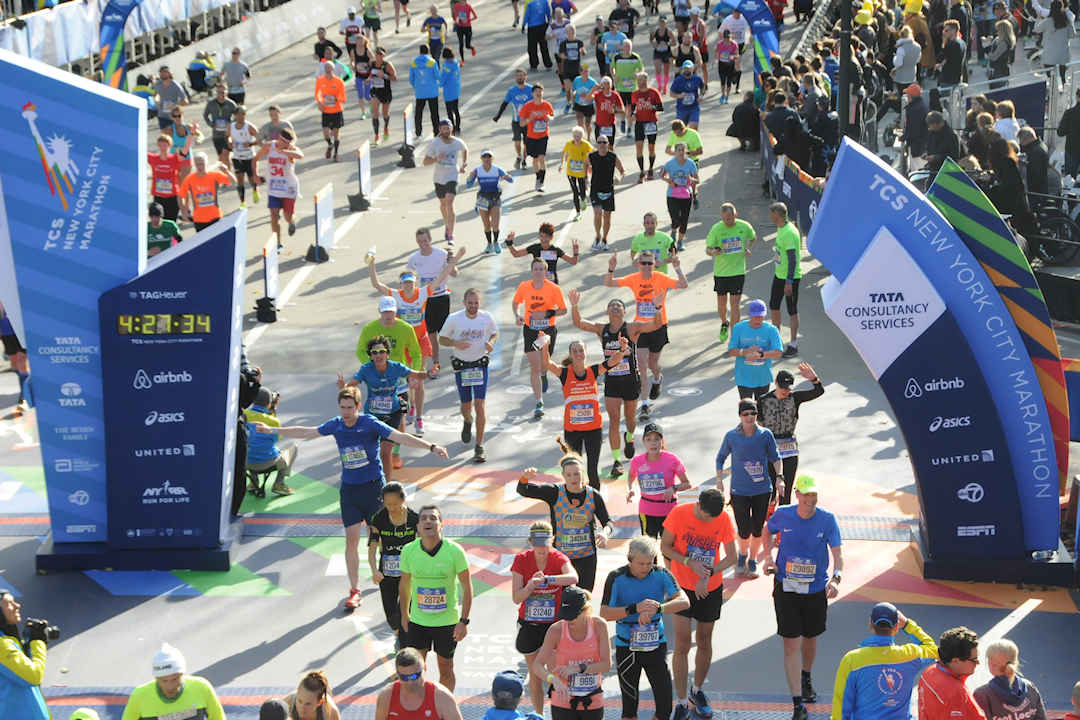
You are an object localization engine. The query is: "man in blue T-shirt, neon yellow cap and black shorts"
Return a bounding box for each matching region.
[764,475,843,720]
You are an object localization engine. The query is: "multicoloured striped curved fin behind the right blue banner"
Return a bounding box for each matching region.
[927,159,1069,493]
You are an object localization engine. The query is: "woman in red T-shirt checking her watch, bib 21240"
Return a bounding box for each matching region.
[510,520,578,715]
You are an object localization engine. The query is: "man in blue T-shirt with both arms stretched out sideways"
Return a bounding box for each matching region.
[255,388,447,610]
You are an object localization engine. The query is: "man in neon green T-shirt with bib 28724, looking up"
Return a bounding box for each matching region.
[401,505,473,692]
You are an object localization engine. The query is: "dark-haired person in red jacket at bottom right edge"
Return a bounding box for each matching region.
[919,627,986,720]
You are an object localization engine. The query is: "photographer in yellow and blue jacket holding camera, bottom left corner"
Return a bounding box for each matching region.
[0,593,56,720]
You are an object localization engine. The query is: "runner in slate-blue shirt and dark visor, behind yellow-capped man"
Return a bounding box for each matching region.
[716,398,784,579]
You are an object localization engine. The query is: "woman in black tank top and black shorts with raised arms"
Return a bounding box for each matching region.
[569,290,657,477]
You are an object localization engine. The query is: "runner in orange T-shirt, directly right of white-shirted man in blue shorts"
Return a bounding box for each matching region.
[513,258,566,420]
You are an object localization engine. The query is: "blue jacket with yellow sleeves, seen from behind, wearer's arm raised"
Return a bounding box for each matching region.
[832,619,937,720]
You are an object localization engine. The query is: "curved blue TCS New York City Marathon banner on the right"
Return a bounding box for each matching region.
[807,139,1059,558]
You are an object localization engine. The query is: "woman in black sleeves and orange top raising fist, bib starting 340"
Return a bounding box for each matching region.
[517,448,615,592]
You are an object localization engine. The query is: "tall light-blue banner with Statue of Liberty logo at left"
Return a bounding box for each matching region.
[0,51,147,542]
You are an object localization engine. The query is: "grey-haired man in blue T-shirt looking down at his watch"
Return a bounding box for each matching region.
[600,536,690,720]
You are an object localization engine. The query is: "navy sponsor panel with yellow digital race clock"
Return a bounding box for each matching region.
[99,210,247,549]
